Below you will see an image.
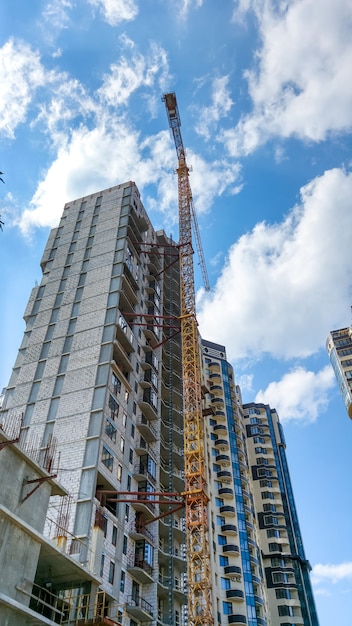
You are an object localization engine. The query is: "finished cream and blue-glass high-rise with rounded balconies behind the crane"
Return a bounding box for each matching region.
[202,340,319,626]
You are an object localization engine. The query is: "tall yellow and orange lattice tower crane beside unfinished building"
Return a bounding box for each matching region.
[163,93,214,626]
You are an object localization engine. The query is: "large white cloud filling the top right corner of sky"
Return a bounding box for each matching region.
[222,0,352,156]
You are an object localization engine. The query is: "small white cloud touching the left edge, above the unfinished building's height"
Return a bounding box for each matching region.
[0,39,45,139]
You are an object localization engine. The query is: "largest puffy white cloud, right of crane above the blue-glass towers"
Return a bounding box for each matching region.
[198,169,352,359]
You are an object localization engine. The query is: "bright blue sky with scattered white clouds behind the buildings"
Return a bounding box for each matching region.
[0,0,352,626]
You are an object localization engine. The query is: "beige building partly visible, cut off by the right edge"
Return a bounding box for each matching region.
[326,326,352,419]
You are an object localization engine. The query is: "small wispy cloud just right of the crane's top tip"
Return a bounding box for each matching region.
[195,76,233,139]
